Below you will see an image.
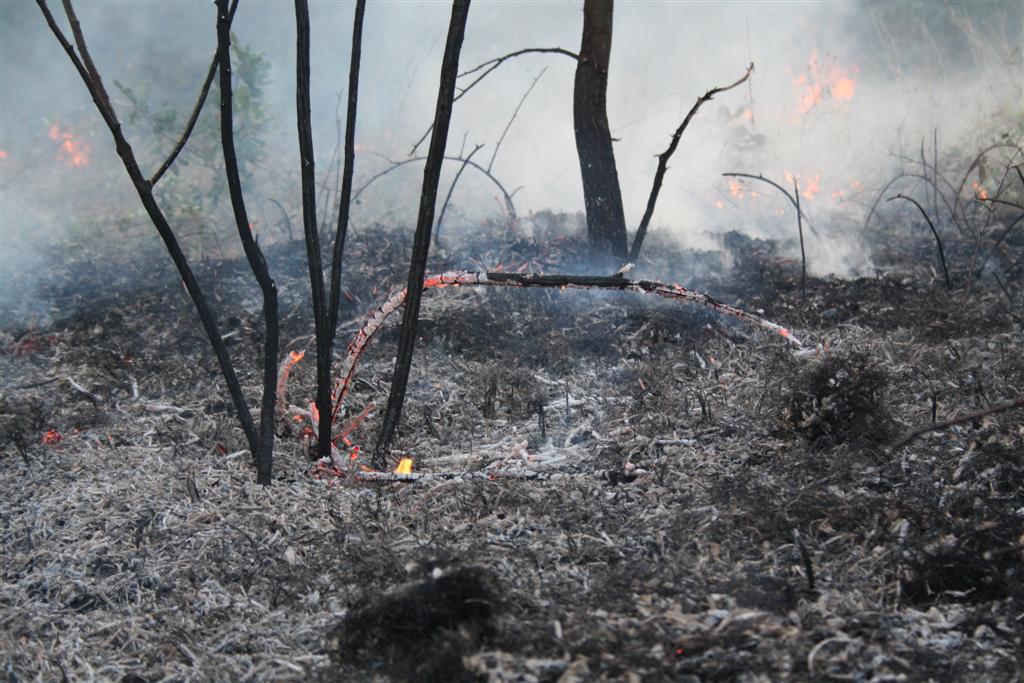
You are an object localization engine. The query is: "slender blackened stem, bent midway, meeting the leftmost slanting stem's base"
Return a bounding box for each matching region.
[217,0,281,485]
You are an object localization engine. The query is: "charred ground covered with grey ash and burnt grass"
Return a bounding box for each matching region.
[0,215,1024,683]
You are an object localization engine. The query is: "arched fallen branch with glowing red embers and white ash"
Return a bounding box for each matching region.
[331,270,802,418]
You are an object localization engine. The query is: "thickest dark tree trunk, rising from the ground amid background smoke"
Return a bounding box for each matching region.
[572,0,627,267]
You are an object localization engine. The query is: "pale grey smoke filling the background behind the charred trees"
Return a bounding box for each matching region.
[0,0,1024,323]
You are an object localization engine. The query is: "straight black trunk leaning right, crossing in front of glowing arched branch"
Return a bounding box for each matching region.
[374,0,471,469]
